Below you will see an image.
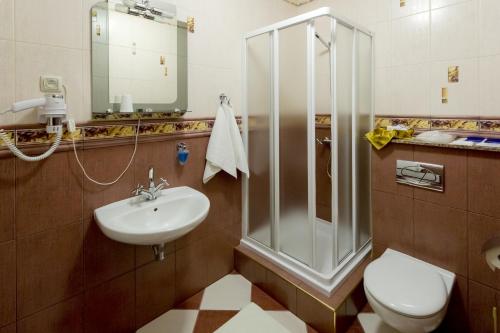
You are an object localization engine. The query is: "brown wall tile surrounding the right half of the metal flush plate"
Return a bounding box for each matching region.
[413,147,467,210]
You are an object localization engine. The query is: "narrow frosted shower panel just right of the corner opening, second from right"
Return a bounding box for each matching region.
[336,24,354,262]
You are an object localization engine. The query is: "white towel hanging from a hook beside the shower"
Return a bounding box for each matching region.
[203,105,249,184]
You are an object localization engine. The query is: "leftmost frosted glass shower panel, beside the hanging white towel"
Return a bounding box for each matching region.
[247,34,273,246]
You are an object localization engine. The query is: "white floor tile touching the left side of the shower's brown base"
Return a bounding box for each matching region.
[200,274,252,310]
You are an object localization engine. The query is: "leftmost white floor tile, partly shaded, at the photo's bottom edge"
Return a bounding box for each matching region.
[137,310,198,333]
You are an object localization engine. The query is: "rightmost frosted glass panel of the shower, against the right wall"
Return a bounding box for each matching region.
[355,32,372,246]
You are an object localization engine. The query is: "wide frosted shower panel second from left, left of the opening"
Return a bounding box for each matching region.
[279,24,314,265]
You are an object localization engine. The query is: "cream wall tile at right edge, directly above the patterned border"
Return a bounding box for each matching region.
[479,55,500,118]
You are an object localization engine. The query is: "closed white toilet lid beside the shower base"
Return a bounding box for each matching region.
[364,256,447,317]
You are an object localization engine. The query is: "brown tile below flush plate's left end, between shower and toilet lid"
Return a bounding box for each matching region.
[372,190,413,255]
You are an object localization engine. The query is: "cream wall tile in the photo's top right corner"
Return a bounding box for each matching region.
[479,0,500,56]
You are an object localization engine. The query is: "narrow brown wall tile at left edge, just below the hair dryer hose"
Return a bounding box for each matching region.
[0,158,16,242]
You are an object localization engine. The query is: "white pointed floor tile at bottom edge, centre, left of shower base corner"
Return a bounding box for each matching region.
[215,303,293,333]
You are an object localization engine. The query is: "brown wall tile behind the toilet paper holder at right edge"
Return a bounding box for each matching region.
[469,213,500,289]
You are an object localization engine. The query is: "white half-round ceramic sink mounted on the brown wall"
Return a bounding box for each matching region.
[94,186,210,245]
